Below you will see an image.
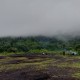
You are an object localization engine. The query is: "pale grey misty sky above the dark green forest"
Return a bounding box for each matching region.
[0,0,80,36]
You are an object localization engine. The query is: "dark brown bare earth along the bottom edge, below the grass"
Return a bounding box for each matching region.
[0,66,80,80]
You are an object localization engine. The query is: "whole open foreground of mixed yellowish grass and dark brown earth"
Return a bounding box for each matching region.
[0,55,80,80]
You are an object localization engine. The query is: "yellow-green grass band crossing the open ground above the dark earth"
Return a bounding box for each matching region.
[0,55,80,78]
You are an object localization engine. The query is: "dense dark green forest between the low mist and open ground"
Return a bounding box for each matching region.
[0,36,80,53]
